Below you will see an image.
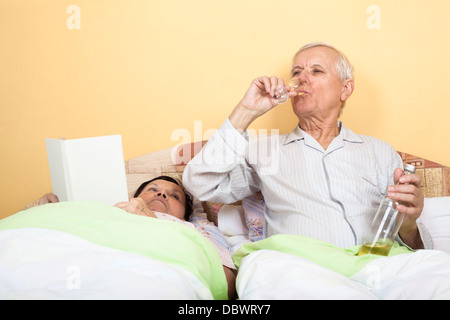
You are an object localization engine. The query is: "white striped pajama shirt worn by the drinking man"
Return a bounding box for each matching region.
[183,119,432,248]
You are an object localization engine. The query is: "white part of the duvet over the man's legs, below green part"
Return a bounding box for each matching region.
[236,250,450,300]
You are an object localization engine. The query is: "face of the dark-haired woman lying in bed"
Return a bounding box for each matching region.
[138,180,186,220]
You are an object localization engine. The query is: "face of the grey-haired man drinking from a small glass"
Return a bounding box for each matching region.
[291,47,353,119]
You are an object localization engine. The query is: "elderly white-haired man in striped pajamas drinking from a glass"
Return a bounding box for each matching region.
[183,43,432,249]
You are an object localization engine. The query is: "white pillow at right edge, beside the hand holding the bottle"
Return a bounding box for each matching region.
[421,197,450,253]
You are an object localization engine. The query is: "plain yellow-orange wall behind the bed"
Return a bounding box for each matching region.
[0,0,450,217]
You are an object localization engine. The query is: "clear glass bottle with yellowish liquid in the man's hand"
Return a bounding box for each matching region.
[358,164,416,256]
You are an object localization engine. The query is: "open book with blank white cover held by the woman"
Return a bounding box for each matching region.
[45,135,128,205]
